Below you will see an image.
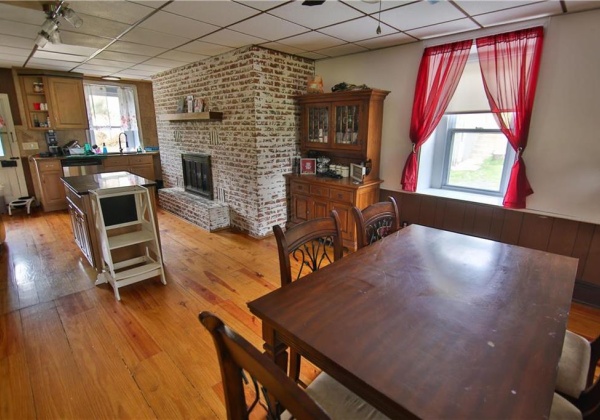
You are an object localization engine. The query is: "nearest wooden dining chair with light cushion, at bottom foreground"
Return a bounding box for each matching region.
[198,311,387,420]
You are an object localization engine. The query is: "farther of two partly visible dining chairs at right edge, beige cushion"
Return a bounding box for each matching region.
[556,330,600,418]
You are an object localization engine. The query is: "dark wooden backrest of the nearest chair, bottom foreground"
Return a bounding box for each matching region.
[198,311,329,420]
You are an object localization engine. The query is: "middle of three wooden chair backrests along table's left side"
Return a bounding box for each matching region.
[273,210,343,286]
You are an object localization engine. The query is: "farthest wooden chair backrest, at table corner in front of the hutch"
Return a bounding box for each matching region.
[352,197,400,249]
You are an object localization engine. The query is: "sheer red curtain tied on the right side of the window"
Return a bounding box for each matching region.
[477,26,544,209]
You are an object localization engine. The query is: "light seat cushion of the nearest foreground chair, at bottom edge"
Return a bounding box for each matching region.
[306,372,388,420]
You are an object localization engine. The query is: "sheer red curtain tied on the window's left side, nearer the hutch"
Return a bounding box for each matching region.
[401,40,473,191]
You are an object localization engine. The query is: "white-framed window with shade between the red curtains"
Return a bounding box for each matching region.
[417,53,515,202]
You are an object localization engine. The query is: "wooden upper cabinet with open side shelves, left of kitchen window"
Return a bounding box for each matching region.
[19,70,88,130]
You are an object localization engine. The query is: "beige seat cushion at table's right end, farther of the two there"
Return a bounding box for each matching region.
[556,330,591,398]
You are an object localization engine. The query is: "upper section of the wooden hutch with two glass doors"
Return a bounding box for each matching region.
[296,89,389,179]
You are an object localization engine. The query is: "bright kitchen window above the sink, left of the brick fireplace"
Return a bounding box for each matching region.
[84,82,143,152]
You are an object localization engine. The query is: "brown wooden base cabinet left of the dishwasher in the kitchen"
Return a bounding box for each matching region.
[33,158,67,211]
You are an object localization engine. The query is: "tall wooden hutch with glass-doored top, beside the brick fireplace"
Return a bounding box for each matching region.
[287,89,389,249]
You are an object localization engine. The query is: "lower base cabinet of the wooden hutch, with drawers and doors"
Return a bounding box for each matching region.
[286,174,382,250]
